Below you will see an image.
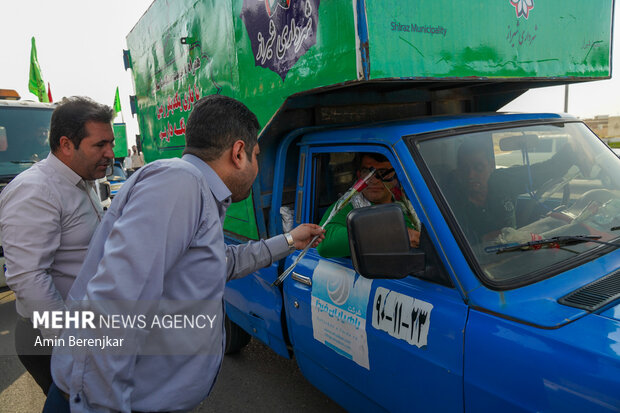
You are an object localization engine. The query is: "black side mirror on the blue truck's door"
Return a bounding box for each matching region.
[347,204,425,278]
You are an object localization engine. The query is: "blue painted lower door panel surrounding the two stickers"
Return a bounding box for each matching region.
[284,254,467,412]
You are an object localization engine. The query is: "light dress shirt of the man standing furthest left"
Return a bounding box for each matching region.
[0,153,103,338]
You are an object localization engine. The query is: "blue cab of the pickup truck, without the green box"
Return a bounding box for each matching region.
[226,114,620,412]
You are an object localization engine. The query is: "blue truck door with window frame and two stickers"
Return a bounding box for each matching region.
[284,146,467,411]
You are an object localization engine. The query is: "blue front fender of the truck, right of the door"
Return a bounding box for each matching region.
[465,311,620,412]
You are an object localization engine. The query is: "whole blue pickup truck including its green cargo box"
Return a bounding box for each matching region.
[124,0,620,412]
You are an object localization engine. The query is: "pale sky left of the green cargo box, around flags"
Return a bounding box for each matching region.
[0,0,153,145]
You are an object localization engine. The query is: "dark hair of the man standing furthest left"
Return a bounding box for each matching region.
[50,96,115,152]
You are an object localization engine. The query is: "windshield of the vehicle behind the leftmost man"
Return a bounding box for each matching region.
[0,106,53,178]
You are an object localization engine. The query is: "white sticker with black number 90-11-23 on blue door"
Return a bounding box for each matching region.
[372,287,433,347]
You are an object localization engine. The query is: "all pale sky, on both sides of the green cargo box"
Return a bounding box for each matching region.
[0,0,620,151]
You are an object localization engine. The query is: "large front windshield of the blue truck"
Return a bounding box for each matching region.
[417,122,620,286]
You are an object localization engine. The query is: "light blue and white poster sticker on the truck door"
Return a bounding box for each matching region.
[311,260,372,369]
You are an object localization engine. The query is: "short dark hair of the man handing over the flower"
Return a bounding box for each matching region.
[184,95,259,161]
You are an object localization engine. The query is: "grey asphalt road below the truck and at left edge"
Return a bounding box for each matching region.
[0,290,344,413]
